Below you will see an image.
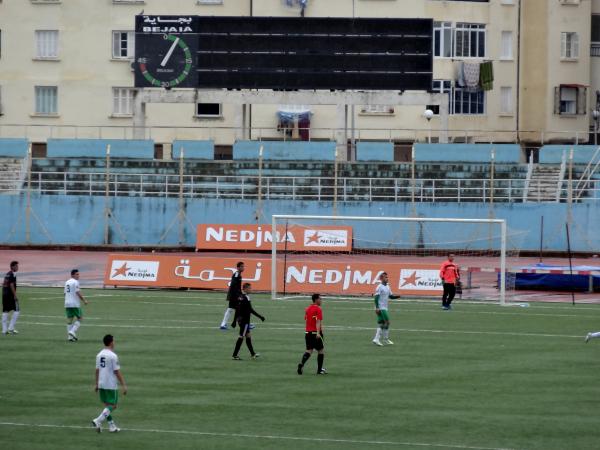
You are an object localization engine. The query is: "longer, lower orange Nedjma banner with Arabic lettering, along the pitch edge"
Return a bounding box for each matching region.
[104,253,442,296]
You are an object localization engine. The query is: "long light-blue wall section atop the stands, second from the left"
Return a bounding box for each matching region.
[47,139,154,160]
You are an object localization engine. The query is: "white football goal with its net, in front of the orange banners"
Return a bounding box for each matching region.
[271,215,524,304]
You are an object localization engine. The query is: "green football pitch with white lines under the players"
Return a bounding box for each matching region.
[0,287,600,450]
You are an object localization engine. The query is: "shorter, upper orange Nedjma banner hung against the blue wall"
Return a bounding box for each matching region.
[196,224,352,252]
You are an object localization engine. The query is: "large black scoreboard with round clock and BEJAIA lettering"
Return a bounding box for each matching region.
[134,15,433,91]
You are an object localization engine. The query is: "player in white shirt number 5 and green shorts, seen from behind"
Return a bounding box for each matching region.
[92,334,127,433]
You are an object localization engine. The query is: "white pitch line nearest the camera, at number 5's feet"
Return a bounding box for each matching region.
[0,422,511,450]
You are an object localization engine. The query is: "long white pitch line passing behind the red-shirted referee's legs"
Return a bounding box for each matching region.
[19,320,584,339]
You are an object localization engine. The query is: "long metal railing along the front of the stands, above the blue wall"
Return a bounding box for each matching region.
[0,172,600,203]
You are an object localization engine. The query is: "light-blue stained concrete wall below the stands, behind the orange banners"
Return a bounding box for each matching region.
[0,195,600,252]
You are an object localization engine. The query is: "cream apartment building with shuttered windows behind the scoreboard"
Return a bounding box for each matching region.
[0,0,600,145]
